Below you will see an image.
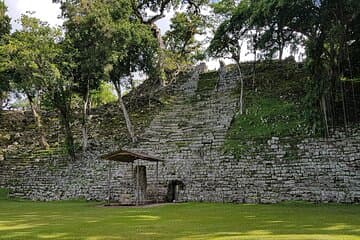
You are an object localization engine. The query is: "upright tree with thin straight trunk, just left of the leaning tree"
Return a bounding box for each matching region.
[62,0,110,152]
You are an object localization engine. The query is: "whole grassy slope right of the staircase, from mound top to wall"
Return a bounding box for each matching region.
[224,61,308,157]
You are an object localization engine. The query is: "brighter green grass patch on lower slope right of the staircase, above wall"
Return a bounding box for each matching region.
[224,94,305,156]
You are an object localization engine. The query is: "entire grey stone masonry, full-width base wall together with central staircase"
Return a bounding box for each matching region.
[0,66,360,203]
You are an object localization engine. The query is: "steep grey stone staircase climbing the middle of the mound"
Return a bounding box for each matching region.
[128,68,238,201]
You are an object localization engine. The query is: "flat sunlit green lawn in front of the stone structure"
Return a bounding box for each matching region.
[0,200,360,240]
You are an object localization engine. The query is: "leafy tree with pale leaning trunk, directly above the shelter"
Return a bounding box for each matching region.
[101,3,158,143]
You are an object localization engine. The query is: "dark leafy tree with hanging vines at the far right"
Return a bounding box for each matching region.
[278,0,360,135]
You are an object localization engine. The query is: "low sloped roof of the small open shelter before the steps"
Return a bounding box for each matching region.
[101,149,164,163]
